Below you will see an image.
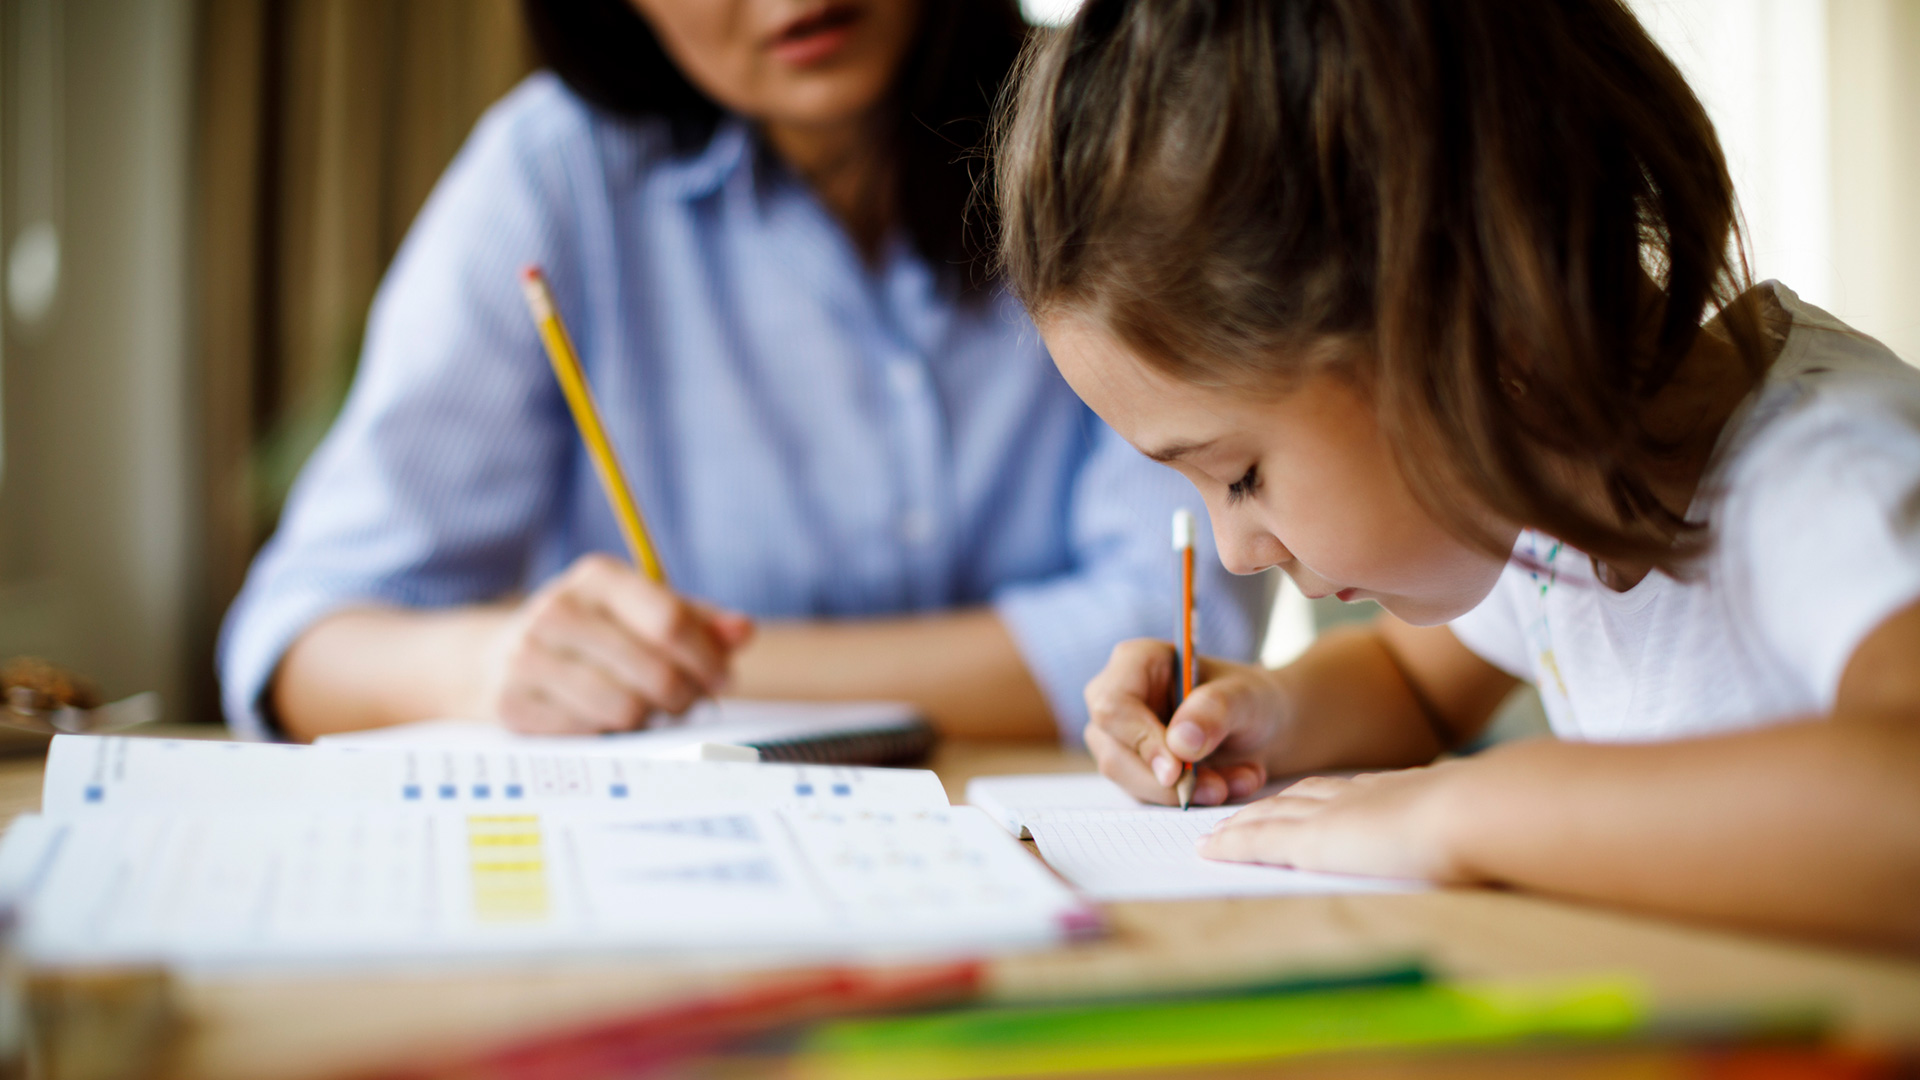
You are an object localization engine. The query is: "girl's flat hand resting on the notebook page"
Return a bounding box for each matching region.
[1200,761,1471,884]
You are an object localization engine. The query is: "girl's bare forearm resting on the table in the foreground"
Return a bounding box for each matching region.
[1436,719,1920,947]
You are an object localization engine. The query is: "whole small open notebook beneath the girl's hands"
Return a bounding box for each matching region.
[966,773,1425,901]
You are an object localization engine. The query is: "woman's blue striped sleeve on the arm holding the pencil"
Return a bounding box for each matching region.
[219,77,589,738]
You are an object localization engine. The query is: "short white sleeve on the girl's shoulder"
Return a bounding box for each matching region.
[1715,390,1920,707]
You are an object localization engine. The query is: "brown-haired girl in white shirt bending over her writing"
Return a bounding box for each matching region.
[998,0,1920,947]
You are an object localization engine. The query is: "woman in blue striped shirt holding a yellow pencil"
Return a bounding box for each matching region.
[221,0,1256,738]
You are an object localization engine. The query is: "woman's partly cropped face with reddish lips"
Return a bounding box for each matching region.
[630,0,920,127]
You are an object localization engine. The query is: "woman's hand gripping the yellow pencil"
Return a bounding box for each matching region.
[480,555,753,734]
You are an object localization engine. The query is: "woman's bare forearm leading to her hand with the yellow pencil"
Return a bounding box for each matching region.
[267,607,513,742]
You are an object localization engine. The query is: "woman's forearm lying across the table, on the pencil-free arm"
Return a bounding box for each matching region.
[732,609,1058,738]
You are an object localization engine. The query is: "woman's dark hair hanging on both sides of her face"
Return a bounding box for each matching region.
[522,0,1027,288]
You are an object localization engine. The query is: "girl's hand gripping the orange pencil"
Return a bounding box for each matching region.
[1087,638,1284,805]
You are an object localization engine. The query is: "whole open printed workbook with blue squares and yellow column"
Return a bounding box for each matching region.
[0,736,1094,969]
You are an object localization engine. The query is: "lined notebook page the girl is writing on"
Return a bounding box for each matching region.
[1027,807,1425,899]
